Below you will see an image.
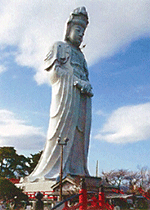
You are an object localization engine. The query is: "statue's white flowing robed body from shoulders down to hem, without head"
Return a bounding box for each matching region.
[28,42,93,181]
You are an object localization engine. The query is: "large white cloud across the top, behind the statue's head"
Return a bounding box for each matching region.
[0,0,150,84]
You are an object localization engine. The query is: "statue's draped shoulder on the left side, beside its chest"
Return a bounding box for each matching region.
[44,41,71,70]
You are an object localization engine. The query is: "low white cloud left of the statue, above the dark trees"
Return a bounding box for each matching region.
[0,110,46,151]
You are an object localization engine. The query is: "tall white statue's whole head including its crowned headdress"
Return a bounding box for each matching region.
[65,7,88,47]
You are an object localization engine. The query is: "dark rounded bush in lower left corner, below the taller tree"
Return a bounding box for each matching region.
[0,177,28,201]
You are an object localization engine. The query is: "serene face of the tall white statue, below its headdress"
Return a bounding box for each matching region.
[69,25,85,47]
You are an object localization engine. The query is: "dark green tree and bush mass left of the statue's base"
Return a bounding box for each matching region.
[0,147,42,205]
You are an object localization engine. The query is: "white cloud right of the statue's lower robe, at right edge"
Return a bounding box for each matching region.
[95,103,150,144]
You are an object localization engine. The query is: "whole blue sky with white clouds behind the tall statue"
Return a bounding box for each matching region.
[0,0,150,176]
